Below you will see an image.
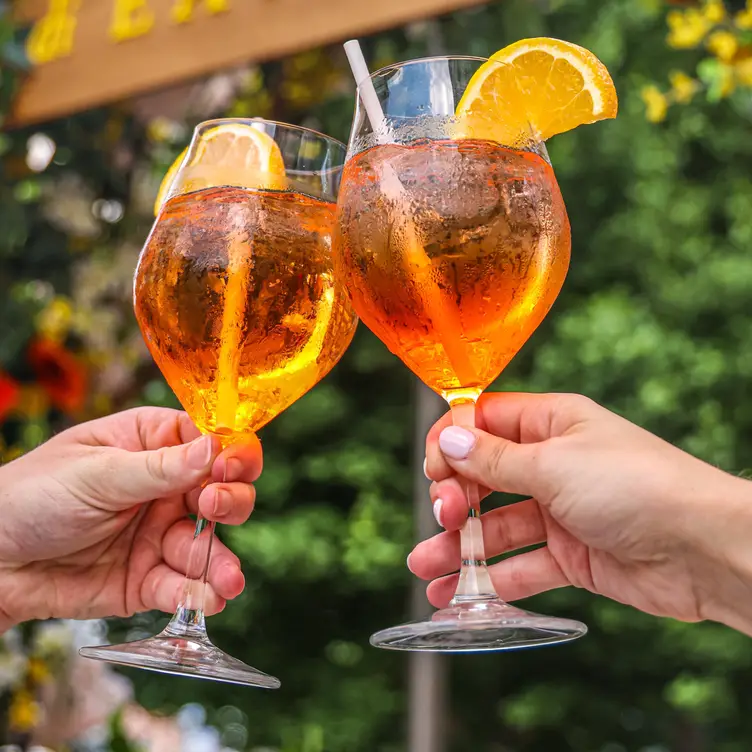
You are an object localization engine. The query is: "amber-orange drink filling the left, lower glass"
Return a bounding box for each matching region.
[135,187,357,436]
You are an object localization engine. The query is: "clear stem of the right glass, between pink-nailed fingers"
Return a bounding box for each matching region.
[450,398,499,606]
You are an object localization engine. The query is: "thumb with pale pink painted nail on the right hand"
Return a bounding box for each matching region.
[439,426,540,496]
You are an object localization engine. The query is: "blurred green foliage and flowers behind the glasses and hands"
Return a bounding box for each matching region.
[0,0,752,752]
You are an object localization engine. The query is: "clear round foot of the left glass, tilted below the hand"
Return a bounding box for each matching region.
[78,632,280,689]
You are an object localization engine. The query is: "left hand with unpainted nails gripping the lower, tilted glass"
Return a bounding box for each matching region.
[0,407,262,632]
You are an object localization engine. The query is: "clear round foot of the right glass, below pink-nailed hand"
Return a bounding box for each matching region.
[371,599,587,653]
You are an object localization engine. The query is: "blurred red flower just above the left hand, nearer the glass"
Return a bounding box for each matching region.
[29,339,87,413]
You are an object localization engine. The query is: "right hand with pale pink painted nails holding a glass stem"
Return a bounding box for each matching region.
[408,394,752,633]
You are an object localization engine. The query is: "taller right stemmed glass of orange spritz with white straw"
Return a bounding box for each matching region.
[334,57,587,652]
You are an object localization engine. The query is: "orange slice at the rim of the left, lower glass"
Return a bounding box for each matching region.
[154,123,286,215]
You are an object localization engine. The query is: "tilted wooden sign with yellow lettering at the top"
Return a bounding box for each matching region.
[11,0,483,125]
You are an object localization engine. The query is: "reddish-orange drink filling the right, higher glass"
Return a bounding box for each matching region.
[334,141,570,397]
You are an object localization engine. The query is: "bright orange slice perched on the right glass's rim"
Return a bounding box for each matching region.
[456,37,618,146]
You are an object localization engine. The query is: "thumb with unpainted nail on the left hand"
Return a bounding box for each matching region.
[108,436,222,504]
